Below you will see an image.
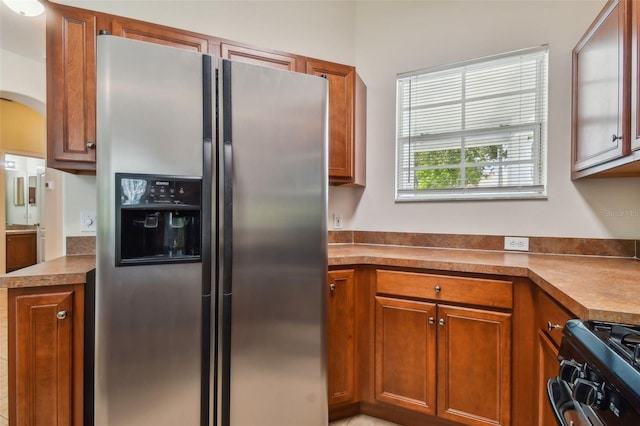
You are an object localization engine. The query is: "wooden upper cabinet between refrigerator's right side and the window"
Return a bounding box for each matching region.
[306,59,366,186]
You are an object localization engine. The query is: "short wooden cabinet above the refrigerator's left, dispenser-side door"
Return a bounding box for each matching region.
[111,17,219,55]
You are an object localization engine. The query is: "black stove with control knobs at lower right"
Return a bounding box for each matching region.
[547,320,640,426]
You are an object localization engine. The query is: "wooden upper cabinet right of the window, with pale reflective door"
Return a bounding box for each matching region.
[572,0,640,179]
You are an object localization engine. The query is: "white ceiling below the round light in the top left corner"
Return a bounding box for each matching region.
[0,3,46,62]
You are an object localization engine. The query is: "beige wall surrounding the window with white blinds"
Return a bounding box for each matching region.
[329,0,640,238]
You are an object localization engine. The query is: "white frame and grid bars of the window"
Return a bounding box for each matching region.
[394,45,549,202]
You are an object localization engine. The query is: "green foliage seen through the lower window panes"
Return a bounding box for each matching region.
[414,145,507,189]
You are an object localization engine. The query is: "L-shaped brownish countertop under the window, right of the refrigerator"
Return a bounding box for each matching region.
[329,244,640,324]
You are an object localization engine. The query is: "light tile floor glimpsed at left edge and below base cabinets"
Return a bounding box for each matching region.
[0,289,398,426]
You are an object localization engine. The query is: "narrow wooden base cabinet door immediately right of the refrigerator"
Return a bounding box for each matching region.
[327,269,356,407]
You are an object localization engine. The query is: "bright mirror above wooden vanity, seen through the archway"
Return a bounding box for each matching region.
[5,154,45,226]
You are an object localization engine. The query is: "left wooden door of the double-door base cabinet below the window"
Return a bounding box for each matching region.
[375,296,436,414]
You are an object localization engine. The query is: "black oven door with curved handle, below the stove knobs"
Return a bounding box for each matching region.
[547,377,605,426]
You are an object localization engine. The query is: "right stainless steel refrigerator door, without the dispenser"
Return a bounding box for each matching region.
[217,61,327,426]
